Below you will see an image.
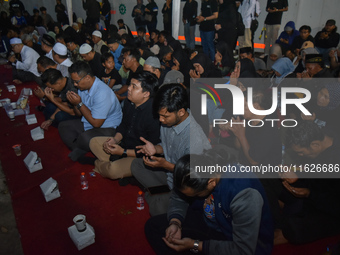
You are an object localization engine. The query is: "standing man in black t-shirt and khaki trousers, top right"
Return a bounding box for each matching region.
[264,0,288,55]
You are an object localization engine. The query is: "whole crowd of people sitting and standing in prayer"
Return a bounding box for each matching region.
[0,0,340,254]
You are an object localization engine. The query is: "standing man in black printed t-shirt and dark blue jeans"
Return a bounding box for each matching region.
[196,0,218,61]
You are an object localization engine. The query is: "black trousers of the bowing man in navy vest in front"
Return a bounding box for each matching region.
[145,208,227,255]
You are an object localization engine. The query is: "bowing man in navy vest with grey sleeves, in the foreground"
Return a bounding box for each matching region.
[145,149,274,255]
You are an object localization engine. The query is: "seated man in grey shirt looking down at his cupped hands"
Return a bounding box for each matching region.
[131,84,211,215]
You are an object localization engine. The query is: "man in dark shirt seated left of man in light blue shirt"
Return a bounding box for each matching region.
[41,68,79,130]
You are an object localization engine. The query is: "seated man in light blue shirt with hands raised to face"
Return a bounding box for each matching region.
[58,61,122,161]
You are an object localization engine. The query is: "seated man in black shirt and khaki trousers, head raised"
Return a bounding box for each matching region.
[90,72,160,179]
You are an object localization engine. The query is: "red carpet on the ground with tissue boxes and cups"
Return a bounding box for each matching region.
[0,67,339,255]
